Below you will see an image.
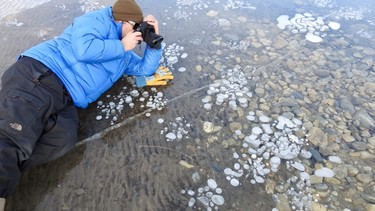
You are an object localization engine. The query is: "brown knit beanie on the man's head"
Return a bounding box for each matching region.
[112,0,143,23]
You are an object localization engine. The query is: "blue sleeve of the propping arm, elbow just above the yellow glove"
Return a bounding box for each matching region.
[124,45,163,76]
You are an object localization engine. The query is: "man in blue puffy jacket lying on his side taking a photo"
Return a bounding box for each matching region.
[0,0,167,210]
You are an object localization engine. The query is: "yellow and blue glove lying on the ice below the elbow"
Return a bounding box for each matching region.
[135,66,173,87]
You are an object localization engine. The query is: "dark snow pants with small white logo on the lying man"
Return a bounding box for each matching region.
[0,57,79,198]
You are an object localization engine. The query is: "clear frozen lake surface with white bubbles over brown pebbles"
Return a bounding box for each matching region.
[0,0,375,211]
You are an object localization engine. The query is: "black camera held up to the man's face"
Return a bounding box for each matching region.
[134,22,164,49]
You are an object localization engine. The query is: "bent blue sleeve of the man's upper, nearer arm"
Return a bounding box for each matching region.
[71,15,125,63]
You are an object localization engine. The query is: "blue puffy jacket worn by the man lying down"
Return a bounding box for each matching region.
[21,7,162,108]
